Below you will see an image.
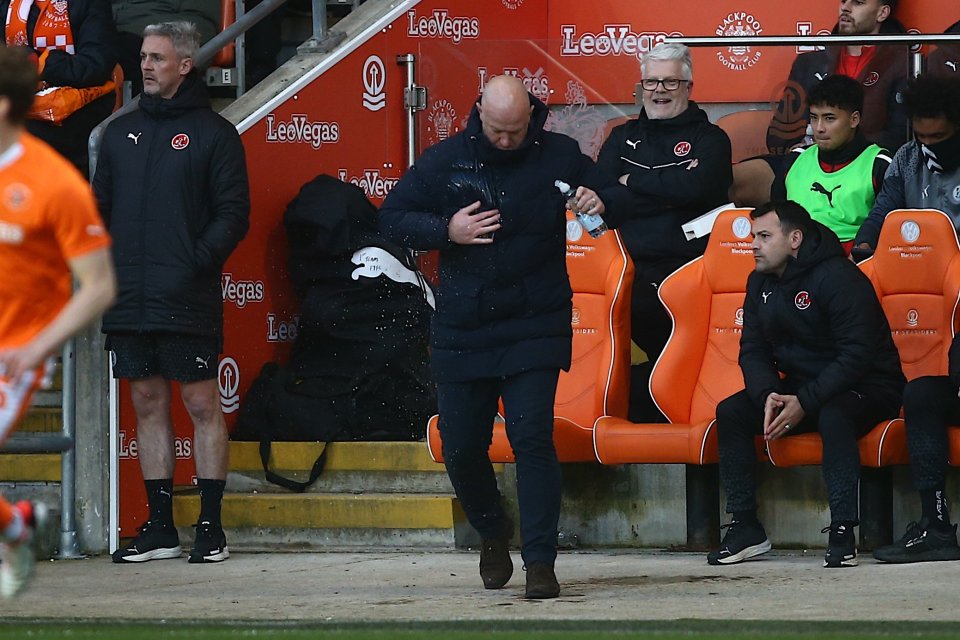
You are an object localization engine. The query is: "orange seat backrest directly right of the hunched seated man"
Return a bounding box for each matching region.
[860,209,960,380]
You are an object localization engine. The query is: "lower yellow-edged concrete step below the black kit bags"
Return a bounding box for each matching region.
[174,492,478,549]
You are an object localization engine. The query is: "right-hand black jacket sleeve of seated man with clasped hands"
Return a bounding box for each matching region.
[797,258,889,413]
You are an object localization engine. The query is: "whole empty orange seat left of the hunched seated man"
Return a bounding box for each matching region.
[593,209,754,548]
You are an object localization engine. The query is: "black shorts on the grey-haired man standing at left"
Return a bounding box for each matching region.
[107,333,222,382]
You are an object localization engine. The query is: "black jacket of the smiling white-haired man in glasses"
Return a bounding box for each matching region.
[597,101,733,262]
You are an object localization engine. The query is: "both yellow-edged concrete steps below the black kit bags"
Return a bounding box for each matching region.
[174,442,488,550]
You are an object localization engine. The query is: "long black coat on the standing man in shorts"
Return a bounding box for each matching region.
[93,72,250,336]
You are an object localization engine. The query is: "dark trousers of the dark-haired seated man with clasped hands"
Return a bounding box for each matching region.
[717,389,900,523]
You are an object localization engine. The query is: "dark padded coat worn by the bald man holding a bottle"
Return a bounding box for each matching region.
[380,95,626,382]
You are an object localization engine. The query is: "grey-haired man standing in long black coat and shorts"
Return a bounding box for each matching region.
[93,22,250,563]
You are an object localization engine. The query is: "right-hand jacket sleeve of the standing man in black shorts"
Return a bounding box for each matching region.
[192,125,250,273]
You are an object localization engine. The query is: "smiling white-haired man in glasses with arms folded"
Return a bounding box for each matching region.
[597,43,733,400]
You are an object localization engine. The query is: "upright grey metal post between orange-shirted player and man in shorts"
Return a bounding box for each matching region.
[57,340,82,560]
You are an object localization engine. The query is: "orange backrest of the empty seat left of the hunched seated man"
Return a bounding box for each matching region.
[650,209,754,424]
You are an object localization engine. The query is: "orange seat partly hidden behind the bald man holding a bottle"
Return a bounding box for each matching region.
[427,213,633,462]
